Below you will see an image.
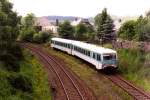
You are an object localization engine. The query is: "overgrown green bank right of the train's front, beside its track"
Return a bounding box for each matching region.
[118,49,150,92]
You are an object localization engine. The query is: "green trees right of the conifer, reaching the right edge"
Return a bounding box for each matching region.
[118,13,150,42]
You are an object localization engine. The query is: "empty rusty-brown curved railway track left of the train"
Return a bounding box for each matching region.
[23,44,95,100]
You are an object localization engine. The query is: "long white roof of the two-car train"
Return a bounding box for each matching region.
[52,38,116,54]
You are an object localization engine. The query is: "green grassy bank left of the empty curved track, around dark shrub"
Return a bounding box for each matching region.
[0,50,51,100]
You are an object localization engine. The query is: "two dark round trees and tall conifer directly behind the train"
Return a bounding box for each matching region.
[58,8,116,43]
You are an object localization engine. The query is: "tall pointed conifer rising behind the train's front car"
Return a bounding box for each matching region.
[95,8,114,43]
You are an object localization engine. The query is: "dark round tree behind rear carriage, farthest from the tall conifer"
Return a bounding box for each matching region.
[58,21,74,39]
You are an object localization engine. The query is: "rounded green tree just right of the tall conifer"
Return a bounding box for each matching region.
[118,20,137,40]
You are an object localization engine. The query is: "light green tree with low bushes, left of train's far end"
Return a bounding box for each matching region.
[19,14,52,43]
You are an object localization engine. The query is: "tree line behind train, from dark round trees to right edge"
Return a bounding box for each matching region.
[58,8,150,44]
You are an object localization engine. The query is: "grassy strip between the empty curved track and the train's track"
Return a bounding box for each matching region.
[43,45,132,100]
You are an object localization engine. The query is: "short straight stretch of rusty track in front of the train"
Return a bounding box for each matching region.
[105,74,150,100]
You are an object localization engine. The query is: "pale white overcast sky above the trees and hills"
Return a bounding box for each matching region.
[9,0,150,17]
